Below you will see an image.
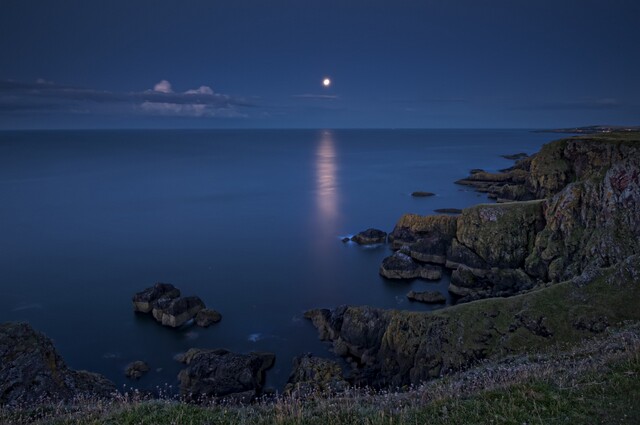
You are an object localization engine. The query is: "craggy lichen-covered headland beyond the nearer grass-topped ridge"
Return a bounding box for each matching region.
[389,134,640,301]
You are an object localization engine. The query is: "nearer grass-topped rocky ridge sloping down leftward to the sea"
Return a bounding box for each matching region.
[305,255,640,386]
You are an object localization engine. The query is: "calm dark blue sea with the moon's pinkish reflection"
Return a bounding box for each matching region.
[0,130,554,388]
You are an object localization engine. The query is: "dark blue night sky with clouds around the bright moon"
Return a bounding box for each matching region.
[0,0,640,129]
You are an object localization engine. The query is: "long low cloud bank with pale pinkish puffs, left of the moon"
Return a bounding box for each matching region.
[0,79,254,117]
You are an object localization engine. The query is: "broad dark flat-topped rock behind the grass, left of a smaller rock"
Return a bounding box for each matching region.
[178,348,275,402]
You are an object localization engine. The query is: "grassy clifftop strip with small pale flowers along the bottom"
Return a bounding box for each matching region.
[5,323,640,425]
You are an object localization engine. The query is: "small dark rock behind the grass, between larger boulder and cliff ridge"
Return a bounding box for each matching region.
[285,354,349,396]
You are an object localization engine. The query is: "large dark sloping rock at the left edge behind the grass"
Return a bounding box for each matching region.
[0,323,116,406]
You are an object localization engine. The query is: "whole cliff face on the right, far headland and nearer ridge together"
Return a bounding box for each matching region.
[307,133,640,386]
